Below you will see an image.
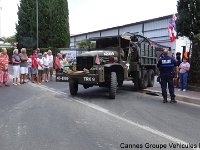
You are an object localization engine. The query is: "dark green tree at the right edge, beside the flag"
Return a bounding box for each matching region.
[176,0,200,84]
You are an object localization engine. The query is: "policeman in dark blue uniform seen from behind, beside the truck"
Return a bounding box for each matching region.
[157,49,177,103]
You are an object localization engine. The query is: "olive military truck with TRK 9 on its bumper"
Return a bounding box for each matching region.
[67,33,162,99]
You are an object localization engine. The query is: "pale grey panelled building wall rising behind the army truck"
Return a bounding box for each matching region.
[70,15,186,51]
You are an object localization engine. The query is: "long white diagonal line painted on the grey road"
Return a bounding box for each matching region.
[27,86,200,150]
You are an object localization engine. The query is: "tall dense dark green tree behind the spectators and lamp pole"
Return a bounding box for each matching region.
[16,0,70,48]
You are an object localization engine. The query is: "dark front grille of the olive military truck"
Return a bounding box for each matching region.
[76,57,94,71]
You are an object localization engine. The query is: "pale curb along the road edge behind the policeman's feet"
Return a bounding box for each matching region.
[143,89,200,105]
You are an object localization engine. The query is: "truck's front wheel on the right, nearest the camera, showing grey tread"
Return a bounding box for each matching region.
[109,72,117,99]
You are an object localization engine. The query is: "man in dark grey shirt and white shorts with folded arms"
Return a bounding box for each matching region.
[19,48,28,84]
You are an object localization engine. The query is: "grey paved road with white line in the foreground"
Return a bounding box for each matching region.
[0,79,200,150]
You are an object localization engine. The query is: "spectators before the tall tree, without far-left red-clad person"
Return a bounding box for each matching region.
[12,48,54,85]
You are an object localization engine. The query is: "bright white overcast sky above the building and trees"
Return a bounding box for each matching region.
[0,0,177,37]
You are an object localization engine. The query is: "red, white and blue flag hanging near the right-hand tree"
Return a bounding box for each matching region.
[168,15,176,42]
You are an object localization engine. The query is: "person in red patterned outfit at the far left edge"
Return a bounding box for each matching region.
[0,48,10,87]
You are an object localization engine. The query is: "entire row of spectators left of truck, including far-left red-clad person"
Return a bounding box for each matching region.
[0,48,68,87]
